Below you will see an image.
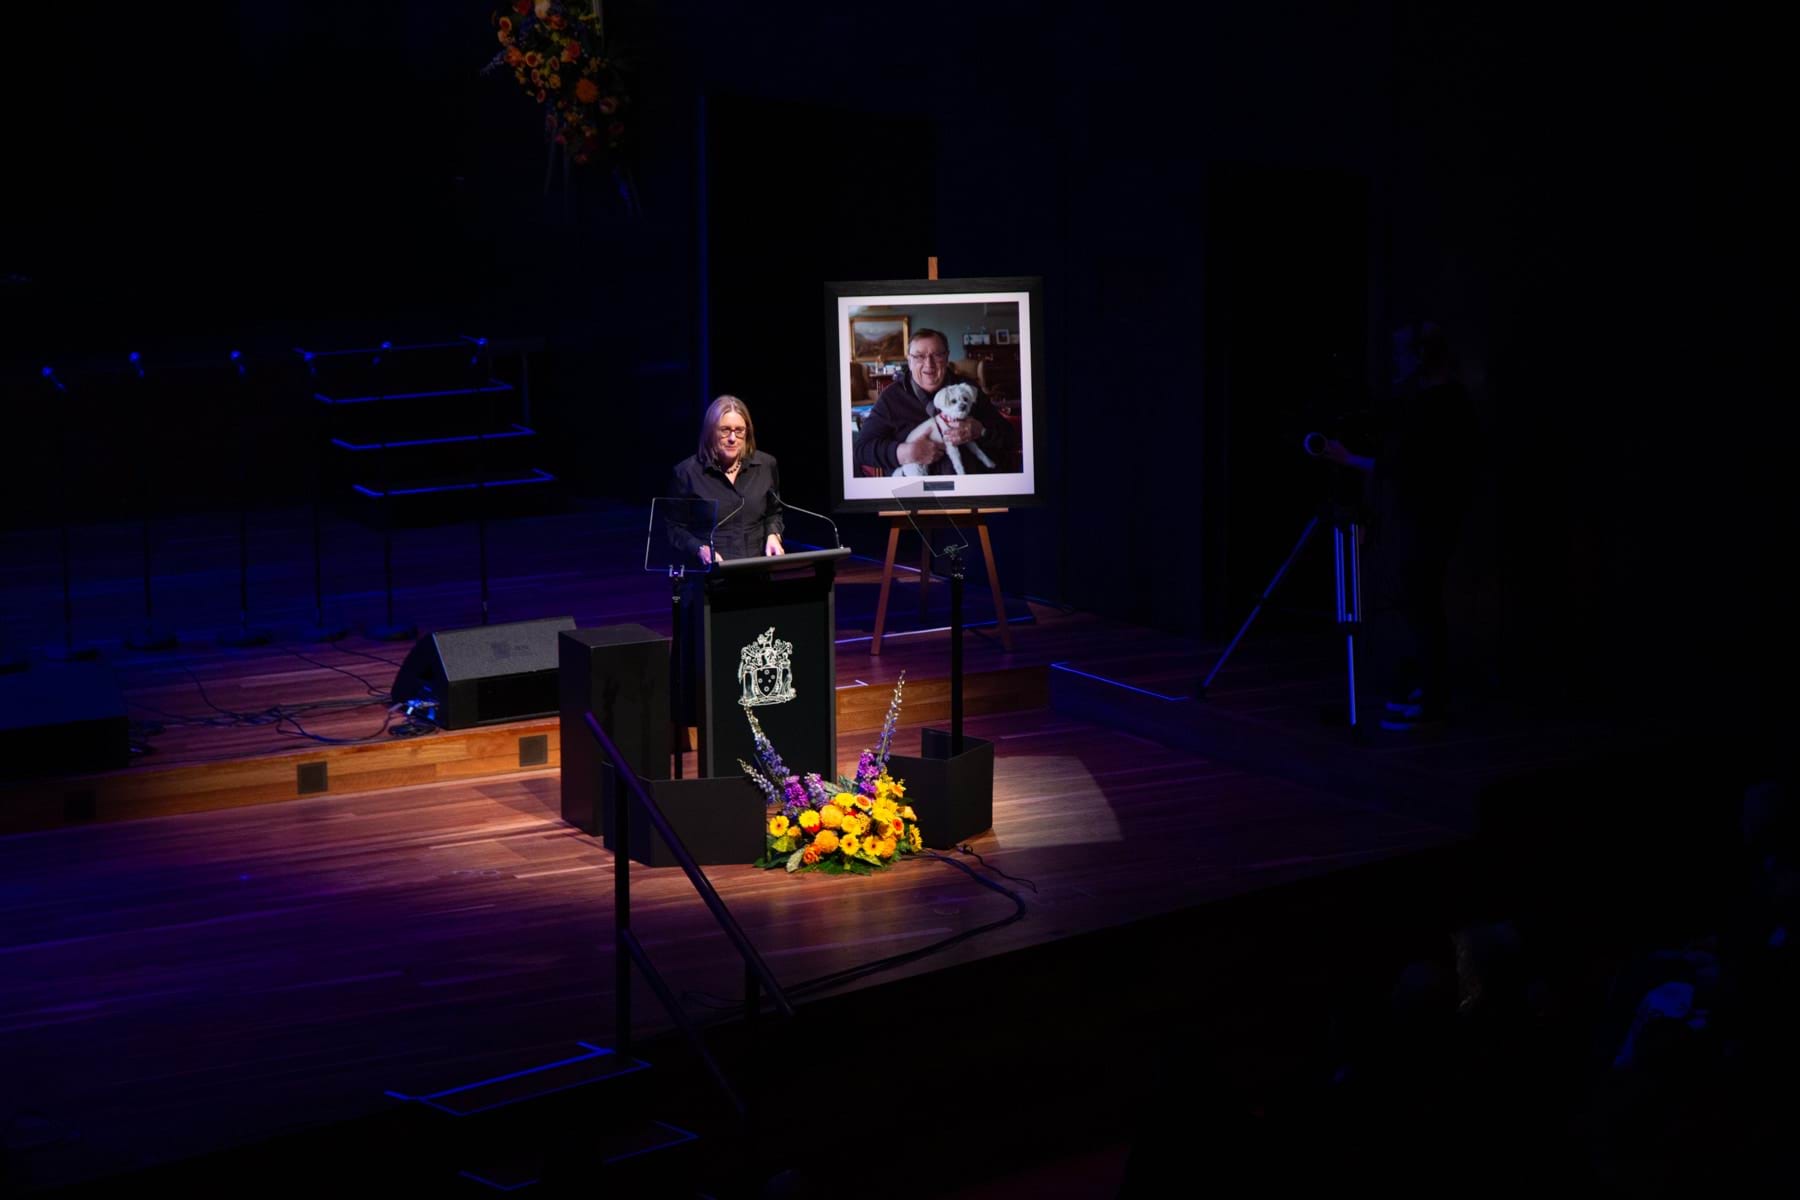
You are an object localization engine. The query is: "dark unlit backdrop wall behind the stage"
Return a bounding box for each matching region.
[0,0,1795,703]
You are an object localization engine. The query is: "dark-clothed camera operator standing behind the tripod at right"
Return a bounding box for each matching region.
[1318,320,1480,730]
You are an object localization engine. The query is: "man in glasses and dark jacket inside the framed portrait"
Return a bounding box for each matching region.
[851,329,1019,475]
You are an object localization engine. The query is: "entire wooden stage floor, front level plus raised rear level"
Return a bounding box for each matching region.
[0,511,1684,1189]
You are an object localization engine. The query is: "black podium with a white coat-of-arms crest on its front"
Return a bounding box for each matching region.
[698,547,850,777]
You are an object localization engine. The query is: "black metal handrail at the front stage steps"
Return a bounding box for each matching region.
[583,711,794,1065]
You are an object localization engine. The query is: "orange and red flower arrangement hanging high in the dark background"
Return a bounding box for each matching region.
[488,0,630,164]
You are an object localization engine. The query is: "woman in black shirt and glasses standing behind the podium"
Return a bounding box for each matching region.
[670,396,785,734]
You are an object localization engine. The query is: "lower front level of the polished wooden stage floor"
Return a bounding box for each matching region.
[0,711,1456,1182]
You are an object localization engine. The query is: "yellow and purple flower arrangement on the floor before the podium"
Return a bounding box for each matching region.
[738,673,925,874]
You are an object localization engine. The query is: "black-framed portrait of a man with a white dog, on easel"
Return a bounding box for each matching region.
[824,275,1044,513]
